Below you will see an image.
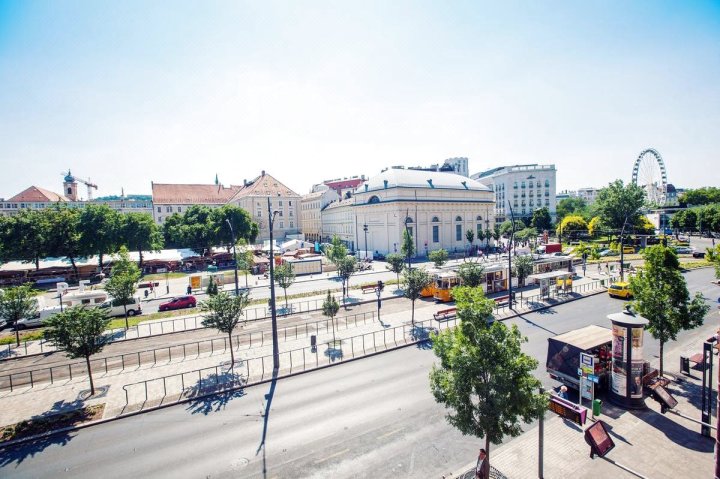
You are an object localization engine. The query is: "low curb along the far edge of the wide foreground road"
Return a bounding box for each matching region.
[0,289,606,450]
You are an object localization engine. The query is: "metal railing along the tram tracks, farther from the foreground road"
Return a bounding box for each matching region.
[0,311,375,392]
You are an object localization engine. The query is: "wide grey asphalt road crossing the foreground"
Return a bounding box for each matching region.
[0,270,720,478]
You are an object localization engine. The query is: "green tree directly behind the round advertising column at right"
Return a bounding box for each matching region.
[630,245,710,376]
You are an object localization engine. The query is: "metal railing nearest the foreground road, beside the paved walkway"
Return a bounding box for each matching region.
[123,319,457,413]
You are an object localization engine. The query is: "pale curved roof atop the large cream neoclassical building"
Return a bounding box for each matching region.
[356,168,492,194]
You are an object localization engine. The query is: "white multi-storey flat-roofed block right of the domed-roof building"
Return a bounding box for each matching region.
[471,164,557,223]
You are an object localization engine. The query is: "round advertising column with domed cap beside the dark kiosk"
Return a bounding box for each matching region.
[608,307,648,409]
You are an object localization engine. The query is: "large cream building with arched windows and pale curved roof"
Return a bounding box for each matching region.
[350,168,495,256]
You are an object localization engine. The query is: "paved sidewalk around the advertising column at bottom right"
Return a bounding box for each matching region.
[447,316,720,479]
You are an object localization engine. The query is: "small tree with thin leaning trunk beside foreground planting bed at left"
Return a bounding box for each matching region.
[44,306,110,396]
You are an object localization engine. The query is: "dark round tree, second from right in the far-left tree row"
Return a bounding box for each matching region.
[78,204,121,271]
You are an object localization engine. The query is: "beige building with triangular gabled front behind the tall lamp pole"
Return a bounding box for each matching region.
[228,170,301,241]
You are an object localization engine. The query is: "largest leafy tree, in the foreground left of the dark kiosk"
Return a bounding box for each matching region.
[430,290,548,470]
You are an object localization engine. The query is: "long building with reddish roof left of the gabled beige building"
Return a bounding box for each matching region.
[152,182,242,225]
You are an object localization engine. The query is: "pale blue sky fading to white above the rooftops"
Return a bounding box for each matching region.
[0,0,720,198]
